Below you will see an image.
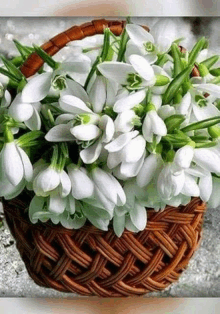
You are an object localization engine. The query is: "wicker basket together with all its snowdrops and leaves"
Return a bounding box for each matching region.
[0,20,220,297]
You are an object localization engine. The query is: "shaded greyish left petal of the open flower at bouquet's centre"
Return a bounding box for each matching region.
[45,124,74,142]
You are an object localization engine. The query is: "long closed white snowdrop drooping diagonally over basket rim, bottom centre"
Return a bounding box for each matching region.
[91,167,126,217]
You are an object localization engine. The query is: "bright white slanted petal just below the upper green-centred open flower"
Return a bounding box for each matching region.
[113,90,146,113]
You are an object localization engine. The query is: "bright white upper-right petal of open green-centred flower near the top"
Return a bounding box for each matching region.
[129,55,154,81]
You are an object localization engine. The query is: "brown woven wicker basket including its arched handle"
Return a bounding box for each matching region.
[3,20,206,297]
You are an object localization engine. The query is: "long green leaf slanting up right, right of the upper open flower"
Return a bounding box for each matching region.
[163,66,192,105]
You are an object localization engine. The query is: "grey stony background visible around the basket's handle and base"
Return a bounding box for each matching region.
[0,17,220,298]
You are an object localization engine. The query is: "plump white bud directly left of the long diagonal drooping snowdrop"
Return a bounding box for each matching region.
[67,164,94,200]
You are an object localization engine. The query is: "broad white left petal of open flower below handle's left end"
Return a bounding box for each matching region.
[22,72,52,103]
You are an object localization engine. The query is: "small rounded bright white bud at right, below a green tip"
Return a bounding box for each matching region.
[174,145,194,168]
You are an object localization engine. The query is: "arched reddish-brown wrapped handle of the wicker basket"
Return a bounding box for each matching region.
[20,19,126,78]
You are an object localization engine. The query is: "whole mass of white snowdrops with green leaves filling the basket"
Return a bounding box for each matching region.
[0,20,220,236]
